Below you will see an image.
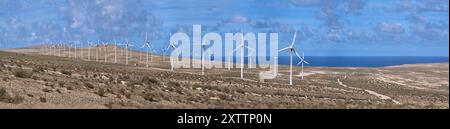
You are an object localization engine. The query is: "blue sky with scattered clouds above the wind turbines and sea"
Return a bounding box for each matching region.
[0,0,449,56]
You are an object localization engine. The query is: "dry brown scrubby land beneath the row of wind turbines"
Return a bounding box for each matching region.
[0,46,449,109]
